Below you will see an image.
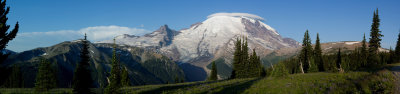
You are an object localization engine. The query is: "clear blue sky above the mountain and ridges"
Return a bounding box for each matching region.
[7,0,400,52]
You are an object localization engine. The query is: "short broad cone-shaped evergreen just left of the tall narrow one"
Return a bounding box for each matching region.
[35,58,57,91]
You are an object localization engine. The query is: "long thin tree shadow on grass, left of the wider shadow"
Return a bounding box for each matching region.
[139,80,225,94]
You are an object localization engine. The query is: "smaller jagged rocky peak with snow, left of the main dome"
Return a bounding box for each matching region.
[96,25,179,48]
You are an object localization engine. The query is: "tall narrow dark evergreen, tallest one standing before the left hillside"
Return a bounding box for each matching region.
[72,34,92,94]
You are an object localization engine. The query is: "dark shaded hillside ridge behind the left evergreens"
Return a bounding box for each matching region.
[3,40,185,87]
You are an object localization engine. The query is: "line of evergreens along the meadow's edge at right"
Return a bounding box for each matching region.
[267,9,400,76]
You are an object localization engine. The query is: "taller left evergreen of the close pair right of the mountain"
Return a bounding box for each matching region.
[300,30,313,73]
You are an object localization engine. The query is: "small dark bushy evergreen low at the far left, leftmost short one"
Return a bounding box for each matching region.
[5,65,24,88]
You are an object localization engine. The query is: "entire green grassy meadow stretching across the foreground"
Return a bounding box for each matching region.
[0,64,400,94]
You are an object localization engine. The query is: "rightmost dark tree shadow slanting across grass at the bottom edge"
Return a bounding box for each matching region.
[214,78,261,94]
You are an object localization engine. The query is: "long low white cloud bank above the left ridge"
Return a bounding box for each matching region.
[7,25,151,52]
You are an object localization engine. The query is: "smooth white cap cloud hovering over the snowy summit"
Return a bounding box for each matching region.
[207,12,264,21]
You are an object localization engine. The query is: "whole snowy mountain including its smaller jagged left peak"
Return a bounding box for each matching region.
[97,13,301,81]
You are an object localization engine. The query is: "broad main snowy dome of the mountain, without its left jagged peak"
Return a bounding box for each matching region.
[161,13,300,65]
